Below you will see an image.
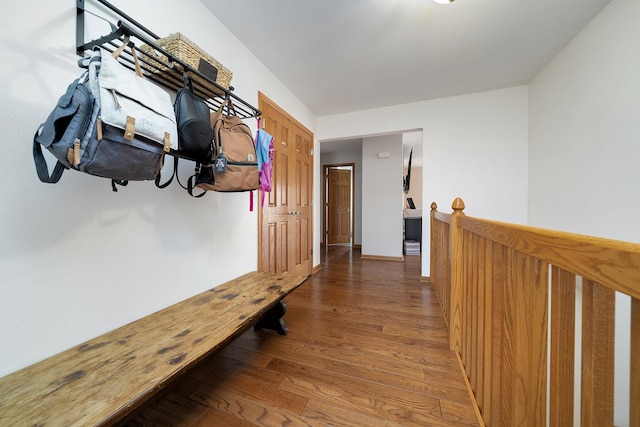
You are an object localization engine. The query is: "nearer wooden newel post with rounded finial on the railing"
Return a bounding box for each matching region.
[449,197,465,354]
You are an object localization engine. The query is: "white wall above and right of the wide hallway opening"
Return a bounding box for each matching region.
[316,86,528,276]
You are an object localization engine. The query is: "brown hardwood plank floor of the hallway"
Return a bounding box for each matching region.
[126,246,478,426]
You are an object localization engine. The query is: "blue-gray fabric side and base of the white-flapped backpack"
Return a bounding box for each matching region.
[33,45,175,191]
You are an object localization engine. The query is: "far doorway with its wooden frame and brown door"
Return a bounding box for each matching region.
[322,163,355,246]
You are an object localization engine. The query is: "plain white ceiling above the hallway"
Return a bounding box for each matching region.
[201,0,610,117]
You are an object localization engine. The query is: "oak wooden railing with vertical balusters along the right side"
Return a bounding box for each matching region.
[431,199,640,427]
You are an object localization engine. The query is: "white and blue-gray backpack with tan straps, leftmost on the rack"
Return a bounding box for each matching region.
[33,39,178,191]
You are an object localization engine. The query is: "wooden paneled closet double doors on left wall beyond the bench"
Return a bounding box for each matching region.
[258,93,313,276]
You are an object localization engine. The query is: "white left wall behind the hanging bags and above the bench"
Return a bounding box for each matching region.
[0,0,320,376]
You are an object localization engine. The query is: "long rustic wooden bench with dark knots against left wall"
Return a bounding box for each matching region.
[0,272,306,426]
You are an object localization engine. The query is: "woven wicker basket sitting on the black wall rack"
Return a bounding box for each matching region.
[140,33,233,94]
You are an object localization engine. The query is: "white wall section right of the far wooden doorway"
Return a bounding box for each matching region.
[362,134,403,258]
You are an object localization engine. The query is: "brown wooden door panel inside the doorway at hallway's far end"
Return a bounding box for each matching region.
[327,167,351,245]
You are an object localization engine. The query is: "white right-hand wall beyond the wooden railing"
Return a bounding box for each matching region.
[529,0,640,426]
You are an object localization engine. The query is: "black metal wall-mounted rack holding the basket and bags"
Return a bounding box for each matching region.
[76,0,262,119]
